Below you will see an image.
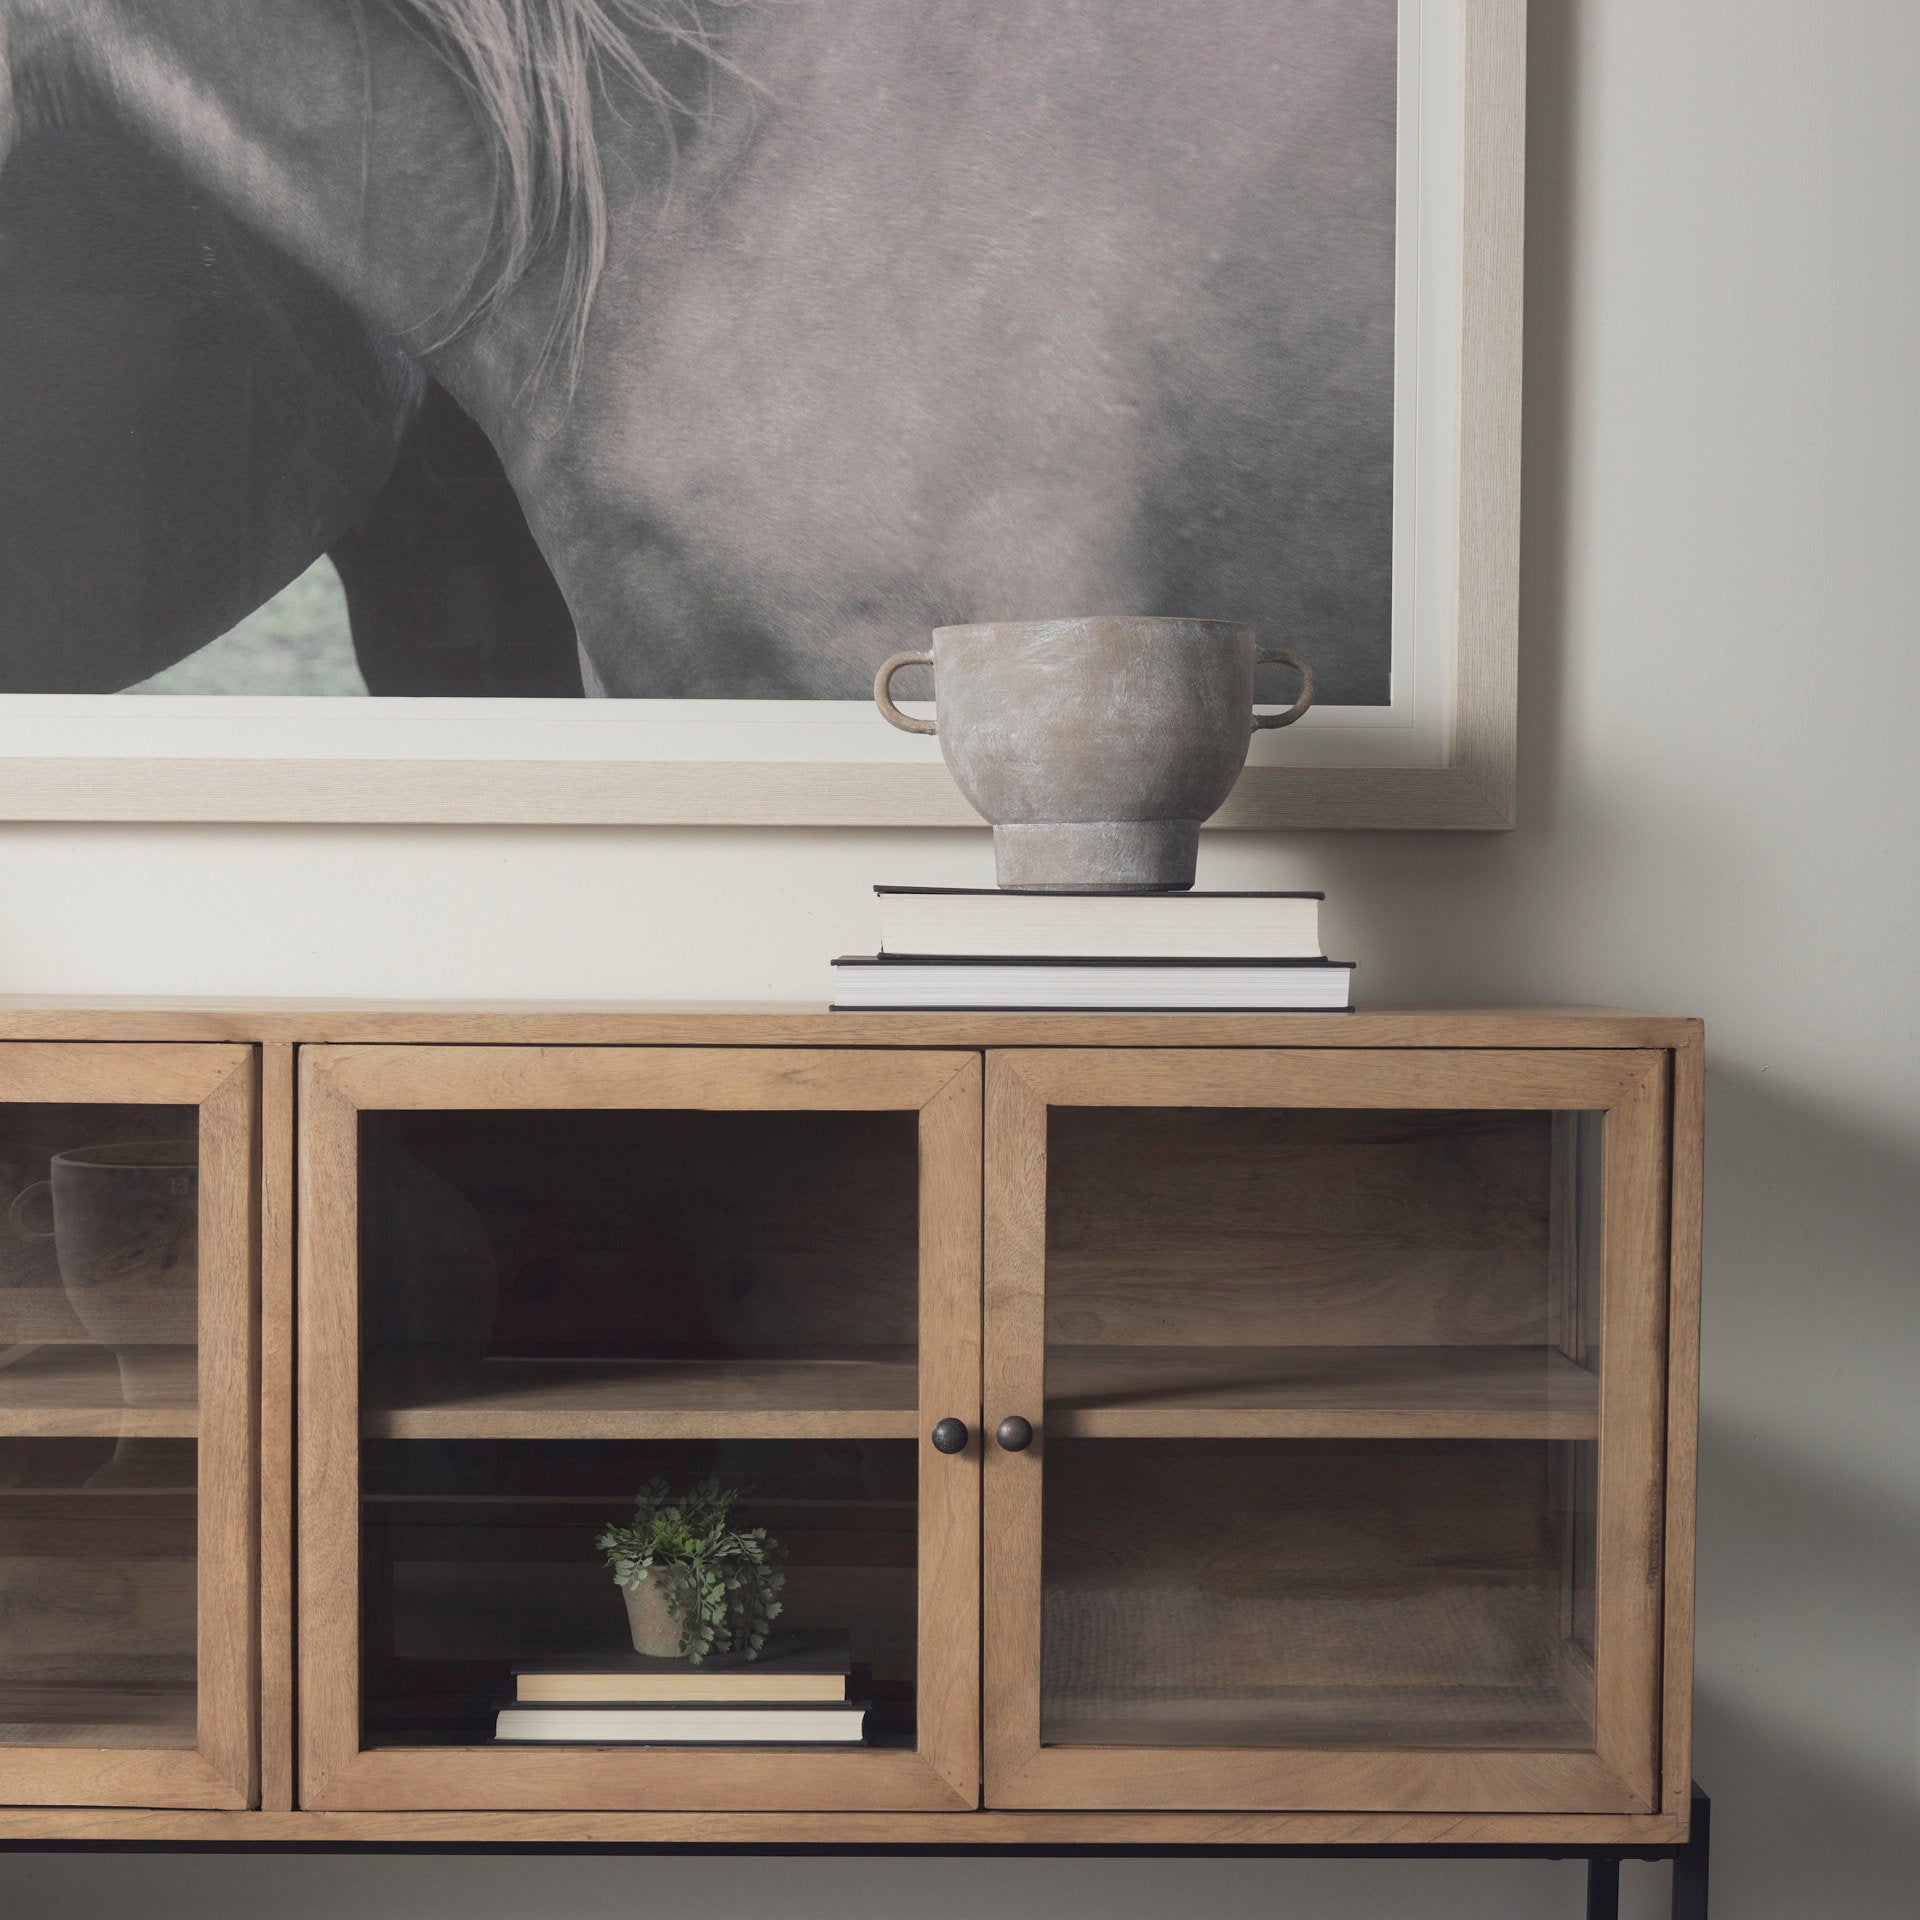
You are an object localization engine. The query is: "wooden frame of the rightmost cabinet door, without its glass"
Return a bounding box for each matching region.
[983,1048,1668,1812]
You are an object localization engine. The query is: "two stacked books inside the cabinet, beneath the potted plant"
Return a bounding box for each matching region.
[493,1632,866,1747]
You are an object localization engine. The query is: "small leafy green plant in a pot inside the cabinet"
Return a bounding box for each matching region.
[595,1478,787,1667]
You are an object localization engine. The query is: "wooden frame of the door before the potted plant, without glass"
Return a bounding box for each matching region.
[298,1046,981,1811]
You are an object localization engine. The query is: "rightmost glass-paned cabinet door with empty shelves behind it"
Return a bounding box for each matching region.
[985,1050,1667,1812]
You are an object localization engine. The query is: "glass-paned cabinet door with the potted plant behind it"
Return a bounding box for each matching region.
[300,1046,981,1809]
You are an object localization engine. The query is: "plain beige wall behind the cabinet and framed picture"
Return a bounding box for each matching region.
[0,0,1920,1920]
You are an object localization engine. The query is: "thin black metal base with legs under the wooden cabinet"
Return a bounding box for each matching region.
[0,1784,1713,1920]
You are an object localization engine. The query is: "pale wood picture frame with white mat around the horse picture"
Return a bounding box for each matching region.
[0,0,1526,829]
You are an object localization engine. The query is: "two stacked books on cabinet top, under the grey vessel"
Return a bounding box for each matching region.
[833,887,1354,1014]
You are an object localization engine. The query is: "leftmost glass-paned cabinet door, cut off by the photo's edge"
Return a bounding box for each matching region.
[0,1041,253,1807]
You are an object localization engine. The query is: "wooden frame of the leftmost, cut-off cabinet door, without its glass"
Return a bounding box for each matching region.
[0,1041,257,1809]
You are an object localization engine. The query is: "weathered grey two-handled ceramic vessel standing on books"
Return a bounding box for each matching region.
[874,614,1313,893]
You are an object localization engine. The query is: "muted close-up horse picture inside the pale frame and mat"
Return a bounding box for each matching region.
[0,0,1398,705]
